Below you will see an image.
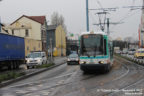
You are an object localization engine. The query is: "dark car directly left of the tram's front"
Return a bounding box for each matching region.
[67,54,79,65]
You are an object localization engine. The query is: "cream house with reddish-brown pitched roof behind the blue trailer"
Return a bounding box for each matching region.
[5,15,47,55]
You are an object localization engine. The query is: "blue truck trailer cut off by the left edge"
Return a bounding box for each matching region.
[0,33,25,69]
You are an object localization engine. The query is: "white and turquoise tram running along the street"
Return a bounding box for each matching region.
[79,31,113,72]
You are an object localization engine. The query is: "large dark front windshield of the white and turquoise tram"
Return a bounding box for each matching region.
[81,34,106,57]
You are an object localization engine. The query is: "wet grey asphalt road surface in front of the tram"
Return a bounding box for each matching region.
[0,57,144,96]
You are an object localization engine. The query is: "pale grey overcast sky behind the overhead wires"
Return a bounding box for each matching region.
[0,0,142,38]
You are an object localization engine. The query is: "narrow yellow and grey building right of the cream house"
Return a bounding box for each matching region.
[47,25,66,56]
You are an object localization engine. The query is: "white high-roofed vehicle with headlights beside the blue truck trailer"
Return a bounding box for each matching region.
[26,51,47,68]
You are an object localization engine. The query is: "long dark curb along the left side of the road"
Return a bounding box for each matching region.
[0,60,66,88]
